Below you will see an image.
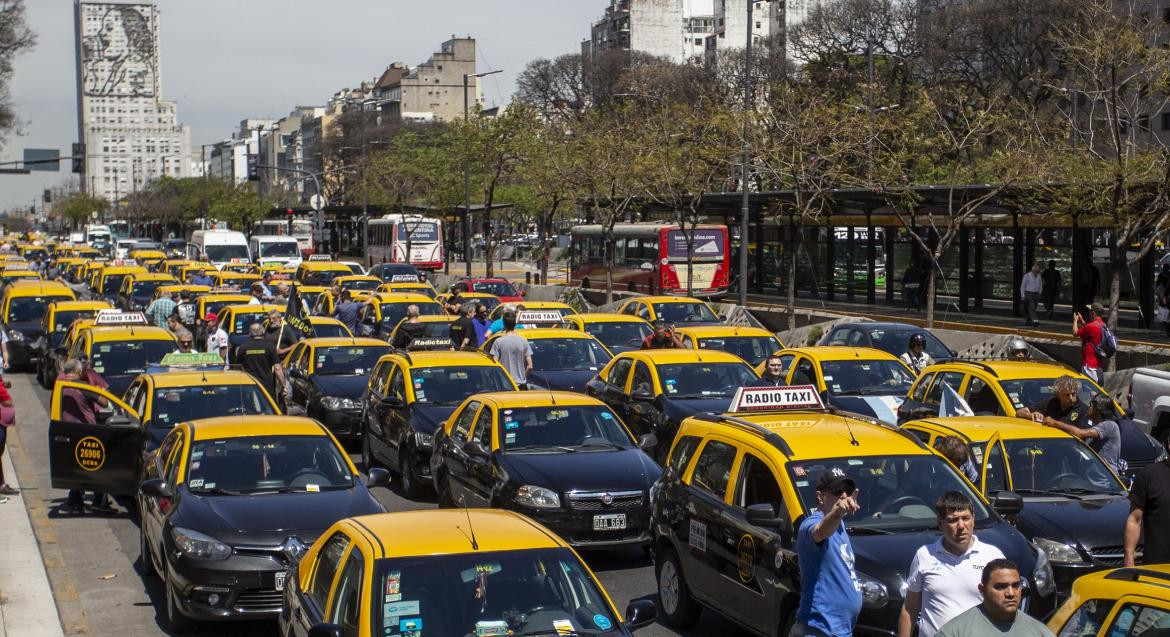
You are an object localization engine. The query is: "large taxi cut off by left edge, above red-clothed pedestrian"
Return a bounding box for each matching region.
[0,281,76,369]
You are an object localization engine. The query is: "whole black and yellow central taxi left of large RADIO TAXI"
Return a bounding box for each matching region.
[431,391,661,547]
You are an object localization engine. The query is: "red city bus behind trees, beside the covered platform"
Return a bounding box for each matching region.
[570,222,731,297]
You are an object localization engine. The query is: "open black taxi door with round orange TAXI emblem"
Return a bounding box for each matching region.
[49,381,145,495]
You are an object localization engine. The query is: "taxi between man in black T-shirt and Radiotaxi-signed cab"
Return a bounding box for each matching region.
[282,337,390,440]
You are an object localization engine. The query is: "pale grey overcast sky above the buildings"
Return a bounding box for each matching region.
[0,0,608,211]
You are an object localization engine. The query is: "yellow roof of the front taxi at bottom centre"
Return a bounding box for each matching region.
[346,509,566,557]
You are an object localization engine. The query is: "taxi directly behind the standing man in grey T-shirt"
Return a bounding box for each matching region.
[483,327,613,392]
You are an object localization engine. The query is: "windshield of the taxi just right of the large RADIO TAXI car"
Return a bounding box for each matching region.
[971,438,1126,495]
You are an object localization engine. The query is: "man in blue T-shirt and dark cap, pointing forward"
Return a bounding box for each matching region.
[791,468,861,637]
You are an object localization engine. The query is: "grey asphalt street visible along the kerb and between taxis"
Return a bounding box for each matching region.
[7,374,748,637]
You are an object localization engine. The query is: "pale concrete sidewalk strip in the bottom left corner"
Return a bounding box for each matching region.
[0,450,64,637]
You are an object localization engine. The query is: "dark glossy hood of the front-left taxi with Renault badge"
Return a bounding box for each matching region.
[173,485,385,546]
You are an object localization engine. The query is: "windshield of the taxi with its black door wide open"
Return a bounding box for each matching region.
[152,385,276,429]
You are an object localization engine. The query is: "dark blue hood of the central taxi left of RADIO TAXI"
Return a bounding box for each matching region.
[495,448,662,493]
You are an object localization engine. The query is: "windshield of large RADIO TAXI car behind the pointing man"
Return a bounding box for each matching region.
[787,451,992,535]
